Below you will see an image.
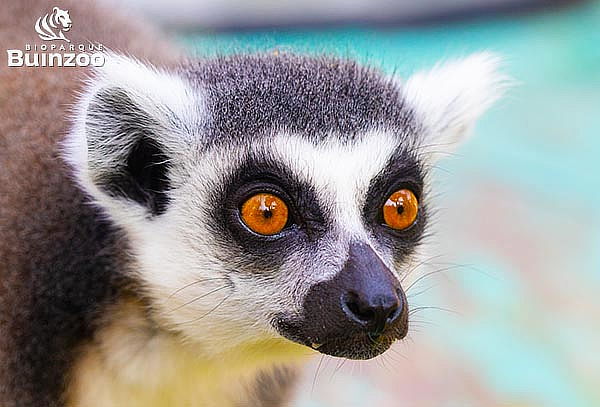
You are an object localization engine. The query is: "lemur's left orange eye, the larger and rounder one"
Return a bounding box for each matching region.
[242,193,288,236]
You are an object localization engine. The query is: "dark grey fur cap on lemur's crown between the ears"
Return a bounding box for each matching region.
[184,54,415,144]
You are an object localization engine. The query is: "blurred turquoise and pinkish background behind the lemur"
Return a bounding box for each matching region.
[119,0,600,407]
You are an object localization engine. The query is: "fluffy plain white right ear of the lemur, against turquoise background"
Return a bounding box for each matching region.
[403,52,508,156]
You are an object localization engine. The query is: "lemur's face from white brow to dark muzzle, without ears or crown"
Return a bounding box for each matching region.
[185,131,427,358]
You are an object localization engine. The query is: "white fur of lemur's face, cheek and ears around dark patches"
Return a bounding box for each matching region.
[66,54,502,360]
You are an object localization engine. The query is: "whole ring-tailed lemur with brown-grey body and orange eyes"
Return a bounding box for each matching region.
[0,0,501,407]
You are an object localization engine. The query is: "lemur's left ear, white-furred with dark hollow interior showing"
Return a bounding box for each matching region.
[66,54,198,220]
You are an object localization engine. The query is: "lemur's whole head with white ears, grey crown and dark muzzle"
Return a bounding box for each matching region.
[67,54,500,359]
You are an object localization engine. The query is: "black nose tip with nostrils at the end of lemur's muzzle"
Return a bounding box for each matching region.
[342,287,403,337]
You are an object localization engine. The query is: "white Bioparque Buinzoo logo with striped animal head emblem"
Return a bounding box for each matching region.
[6,7,105,67]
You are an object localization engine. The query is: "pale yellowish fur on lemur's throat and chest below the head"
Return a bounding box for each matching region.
[66,303,311,407]
